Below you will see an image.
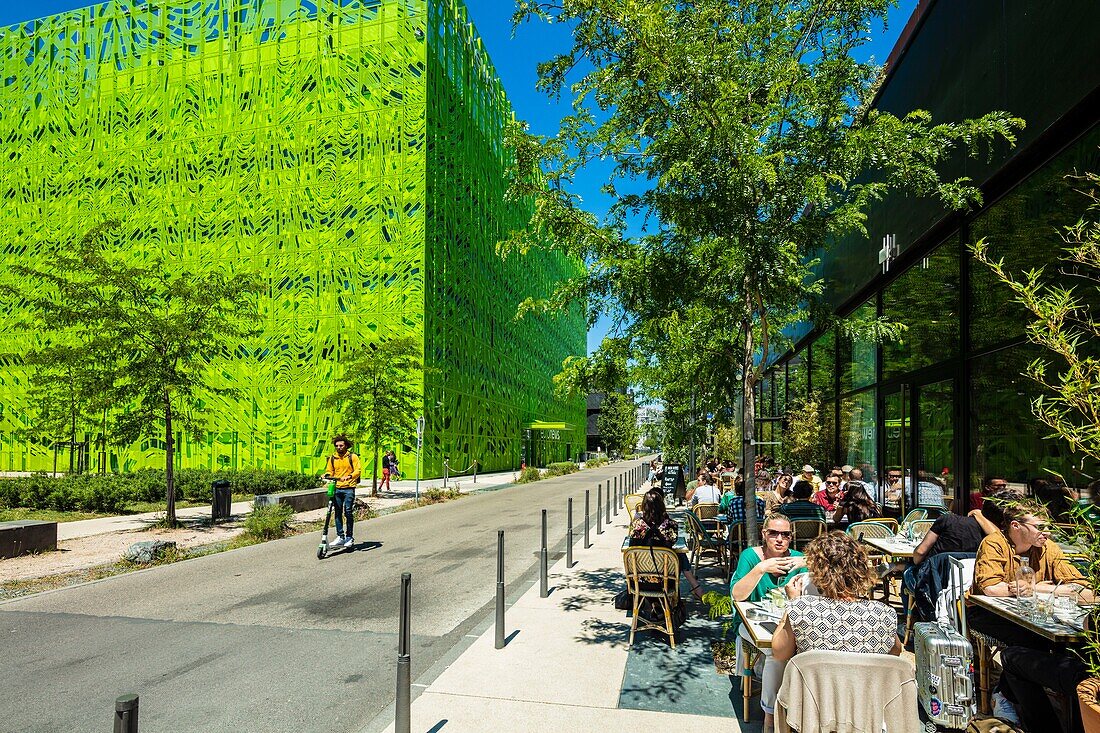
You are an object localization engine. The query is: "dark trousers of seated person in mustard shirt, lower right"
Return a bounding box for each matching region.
[1001,646,1089,733]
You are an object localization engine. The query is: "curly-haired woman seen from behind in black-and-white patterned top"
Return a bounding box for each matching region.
[771,532,902,661]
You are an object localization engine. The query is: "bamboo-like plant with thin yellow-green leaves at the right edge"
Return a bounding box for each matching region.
[970,167,1100,733]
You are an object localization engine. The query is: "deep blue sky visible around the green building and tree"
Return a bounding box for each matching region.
[0,0,917,352]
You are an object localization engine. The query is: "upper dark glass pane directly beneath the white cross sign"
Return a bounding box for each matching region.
[882,237,959,379]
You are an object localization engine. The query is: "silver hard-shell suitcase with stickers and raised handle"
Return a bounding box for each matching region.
[913,558,975,730]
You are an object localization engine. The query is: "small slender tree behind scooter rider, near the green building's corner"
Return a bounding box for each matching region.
[321,337,424,495]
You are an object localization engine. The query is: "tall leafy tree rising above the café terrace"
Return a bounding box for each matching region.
[502,0,1023,537]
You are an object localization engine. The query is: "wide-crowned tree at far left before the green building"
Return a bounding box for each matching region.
[4,220,260,526]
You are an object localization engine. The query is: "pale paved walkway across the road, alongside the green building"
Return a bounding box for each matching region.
[57,464,516,541]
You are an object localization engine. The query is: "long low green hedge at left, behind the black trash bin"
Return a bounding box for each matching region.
[0,469,319,514]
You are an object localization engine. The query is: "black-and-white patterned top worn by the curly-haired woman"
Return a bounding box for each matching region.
[787,595,898,654]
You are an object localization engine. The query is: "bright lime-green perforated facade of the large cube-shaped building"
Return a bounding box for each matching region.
[0,0,584,475]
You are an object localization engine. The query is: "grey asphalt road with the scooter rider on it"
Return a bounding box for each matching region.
[0,463,634,733]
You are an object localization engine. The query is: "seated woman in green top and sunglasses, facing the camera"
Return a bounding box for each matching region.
[729,514,806,731]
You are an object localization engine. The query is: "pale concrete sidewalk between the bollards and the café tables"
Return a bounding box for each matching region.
[362,477,739,733]
